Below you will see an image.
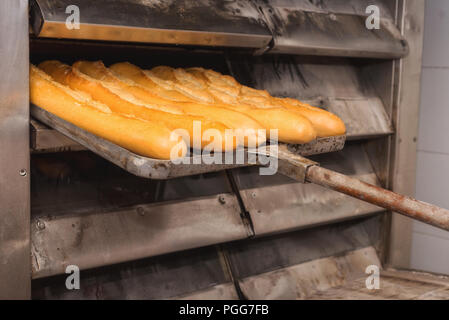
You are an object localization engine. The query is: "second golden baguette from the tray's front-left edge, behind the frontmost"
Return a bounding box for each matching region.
[40,62,237,151]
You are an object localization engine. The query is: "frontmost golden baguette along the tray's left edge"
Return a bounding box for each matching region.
[30,65,186,159]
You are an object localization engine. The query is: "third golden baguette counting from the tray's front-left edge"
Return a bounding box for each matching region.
[109,62,265,146]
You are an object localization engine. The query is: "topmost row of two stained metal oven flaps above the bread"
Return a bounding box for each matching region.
[30,0,409,59]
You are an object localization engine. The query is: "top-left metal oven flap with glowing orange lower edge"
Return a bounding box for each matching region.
[31,0,272,49]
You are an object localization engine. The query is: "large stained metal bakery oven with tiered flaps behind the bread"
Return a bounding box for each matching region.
[0,0,448,299]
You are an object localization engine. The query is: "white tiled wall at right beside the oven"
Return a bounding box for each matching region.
[411,0,449,274]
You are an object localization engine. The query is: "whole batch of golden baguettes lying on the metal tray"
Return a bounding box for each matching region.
[30,61,345,159]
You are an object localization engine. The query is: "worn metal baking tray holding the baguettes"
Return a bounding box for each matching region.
[30,104,346,180]
